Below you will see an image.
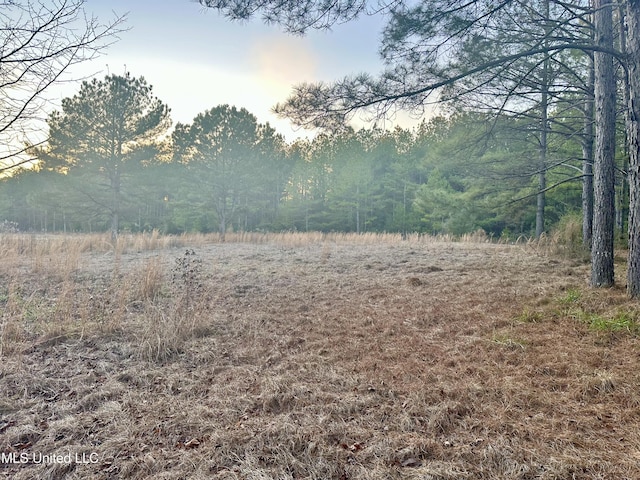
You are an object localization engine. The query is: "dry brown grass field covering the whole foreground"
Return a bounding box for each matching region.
[0,233,640,480]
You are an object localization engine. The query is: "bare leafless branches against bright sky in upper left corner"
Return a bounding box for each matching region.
[0,0,124,173]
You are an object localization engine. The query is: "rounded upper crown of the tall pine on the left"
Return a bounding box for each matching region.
[44,74,170,171]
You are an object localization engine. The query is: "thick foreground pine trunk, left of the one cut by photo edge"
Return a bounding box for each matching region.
[591,0,616,287]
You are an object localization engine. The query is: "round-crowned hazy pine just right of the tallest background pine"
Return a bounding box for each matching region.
[172,105,287,235]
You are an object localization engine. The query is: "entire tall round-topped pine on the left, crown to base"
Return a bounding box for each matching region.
[34,74,170,237]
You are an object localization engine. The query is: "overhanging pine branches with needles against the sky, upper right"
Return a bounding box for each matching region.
[246,0,590,128]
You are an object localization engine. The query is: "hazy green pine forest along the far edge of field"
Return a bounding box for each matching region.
[0,76,604,239]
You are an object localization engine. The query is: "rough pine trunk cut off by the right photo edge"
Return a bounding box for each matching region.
[627,0,640,298]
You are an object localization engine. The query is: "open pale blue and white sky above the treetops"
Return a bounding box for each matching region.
[53,0,408,140]
